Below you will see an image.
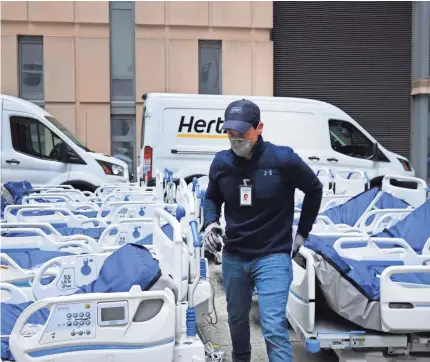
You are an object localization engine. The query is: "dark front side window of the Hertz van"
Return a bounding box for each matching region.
[329,119,373,159]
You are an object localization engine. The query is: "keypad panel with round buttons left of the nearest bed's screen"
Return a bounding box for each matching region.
[40,303,97,344]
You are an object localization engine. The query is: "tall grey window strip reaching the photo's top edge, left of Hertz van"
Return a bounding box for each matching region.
[110,1,135,101]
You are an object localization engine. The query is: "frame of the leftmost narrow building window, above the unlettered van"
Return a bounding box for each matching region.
[17,35,45,108]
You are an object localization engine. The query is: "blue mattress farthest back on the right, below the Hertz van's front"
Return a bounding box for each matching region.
[321,187,410,226]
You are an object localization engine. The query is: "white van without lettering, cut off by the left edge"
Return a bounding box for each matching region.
[0,95,129,191]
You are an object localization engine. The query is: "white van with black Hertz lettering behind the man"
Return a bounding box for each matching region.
[138,93,415,185]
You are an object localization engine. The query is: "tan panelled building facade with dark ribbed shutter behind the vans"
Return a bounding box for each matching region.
[1,1,430,179]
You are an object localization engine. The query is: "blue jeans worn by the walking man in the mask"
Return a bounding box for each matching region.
[222,254,293,362]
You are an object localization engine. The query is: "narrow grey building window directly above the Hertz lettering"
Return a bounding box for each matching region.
[199,40,222,94]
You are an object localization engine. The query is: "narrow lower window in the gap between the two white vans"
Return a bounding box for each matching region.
[111,115,136,174]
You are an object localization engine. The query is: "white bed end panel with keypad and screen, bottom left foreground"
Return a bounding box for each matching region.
[9,286,176,362]
